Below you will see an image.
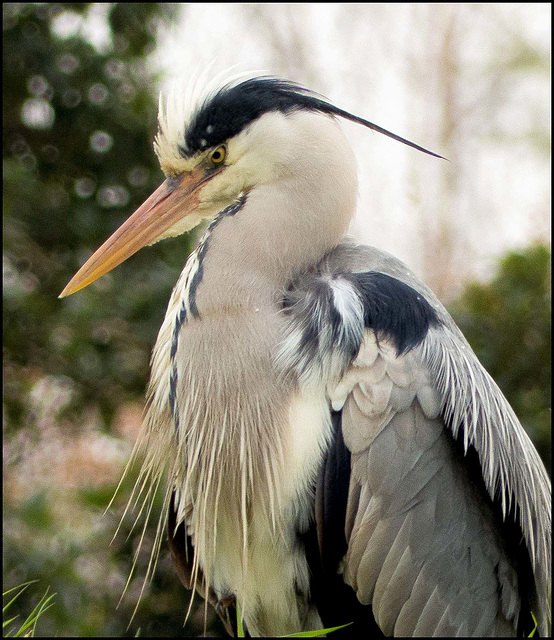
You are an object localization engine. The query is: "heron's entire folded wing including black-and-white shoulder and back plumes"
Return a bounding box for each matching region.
[282,239,551,636]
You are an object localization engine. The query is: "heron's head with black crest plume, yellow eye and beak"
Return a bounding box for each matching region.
[60,76,440,297]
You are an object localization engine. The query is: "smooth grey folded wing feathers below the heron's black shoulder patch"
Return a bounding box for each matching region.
[336,332,520,636]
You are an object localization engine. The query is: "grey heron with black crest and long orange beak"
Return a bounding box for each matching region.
[61,74,551,636]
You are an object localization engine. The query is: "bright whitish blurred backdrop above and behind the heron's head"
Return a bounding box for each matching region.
[146,3,551,297]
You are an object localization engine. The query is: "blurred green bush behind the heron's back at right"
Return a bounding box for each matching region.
[450,244,552,473]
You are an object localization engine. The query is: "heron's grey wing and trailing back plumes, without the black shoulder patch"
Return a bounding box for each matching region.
[284,243,551,636]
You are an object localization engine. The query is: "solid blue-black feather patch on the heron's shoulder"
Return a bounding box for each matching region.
[345,271,439,355]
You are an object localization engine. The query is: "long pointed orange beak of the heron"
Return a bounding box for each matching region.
[59,166,217,298]
